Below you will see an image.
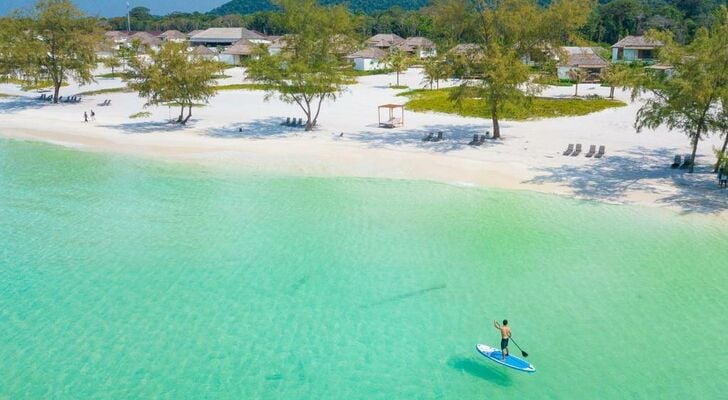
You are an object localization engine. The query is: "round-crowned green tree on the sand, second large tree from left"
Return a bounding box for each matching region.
[129,42,221,125]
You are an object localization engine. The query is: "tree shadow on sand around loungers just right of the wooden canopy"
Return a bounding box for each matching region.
[346,125,503,153]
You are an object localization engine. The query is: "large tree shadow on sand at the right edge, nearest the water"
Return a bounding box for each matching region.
[526,147,728,214]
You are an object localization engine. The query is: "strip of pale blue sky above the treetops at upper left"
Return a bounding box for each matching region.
[0,0,227,17]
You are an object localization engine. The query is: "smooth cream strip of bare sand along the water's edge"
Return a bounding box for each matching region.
[0,123,728,222]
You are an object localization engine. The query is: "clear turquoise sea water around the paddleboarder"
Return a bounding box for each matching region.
[0,141,728,399]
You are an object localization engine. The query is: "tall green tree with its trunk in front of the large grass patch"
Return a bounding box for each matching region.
[451,0,591,138]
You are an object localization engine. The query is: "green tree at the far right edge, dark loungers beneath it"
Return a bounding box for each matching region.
[632,25,728,172]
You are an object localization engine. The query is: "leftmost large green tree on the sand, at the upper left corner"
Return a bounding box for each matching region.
[0,0,103,103]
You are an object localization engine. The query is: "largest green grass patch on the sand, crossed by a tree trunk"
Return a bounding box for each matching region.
[399,88,626,120]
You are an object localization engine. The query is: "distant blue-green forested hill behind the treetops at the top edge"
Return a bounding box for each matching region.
[210,0,429,15]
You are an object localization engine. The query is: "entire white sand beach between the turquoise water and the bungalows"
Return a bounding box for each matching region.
[0,68,728,217]
